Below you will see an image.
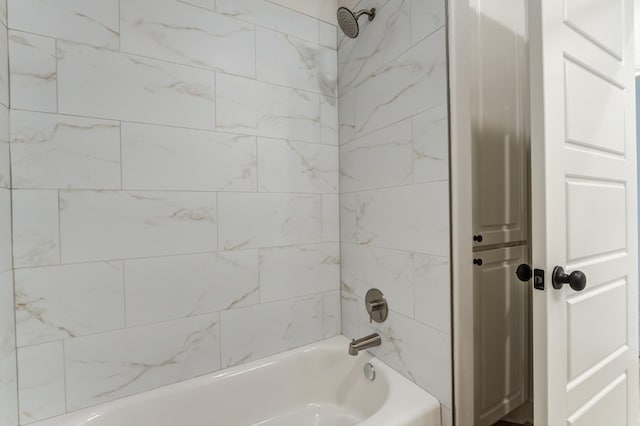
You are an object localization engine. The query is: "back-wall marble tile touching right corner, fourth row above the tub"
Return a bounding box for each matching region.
[258,138,339,193]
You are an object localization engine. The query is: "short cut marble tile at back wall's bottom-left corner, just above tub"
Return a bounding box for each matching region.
[18,342,65,424]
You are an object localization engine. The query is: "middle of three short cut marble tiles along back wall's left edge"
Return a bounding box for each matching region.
[12,190,60,268]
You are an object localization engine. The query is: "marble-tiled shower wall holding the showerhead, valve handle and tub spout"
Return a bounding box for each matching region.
[338,0,452,425]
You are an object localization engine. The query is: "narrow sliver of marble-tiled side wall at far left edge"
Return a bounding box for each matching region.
[0,0,18,426]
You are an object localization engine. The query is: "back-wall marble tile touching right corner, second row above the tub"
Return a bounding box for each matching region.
[260,243,340,302]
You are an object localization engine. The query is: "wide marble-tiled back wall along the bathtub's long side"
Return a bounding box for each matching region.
[6,0,340,426]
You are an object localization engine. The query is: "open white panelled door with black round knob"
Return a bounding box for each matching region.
[529,0,638,426]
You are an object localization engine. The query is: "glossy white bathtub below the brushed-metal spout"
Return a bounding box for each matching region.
[32,336,440,426]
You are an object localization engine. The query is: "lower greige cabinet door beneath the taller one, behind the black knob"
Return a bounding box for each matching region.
[473,246,529,426]
